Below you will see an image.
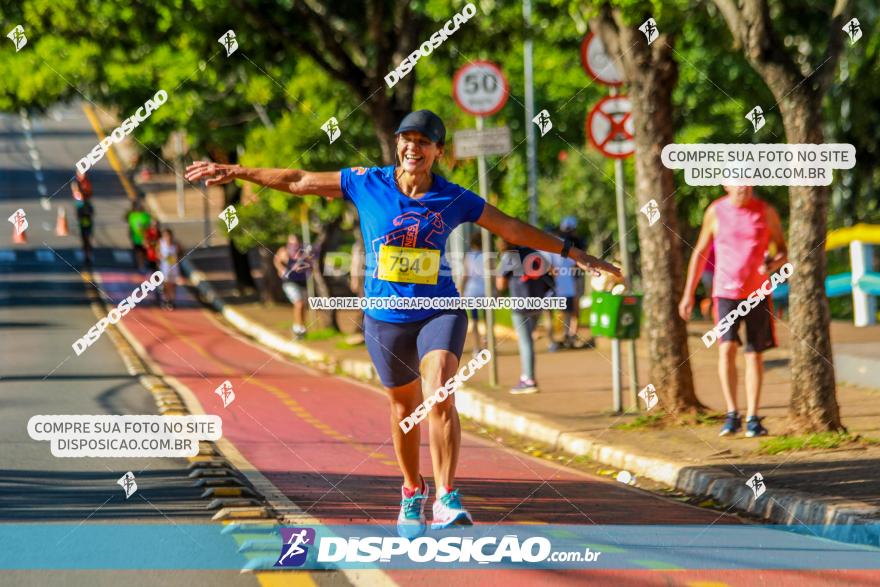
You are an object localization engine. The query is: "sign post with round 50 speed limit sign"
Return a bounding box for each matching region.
[452,61,510,387]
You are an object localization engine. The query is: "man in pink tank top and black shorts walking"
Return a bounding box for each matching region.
[678,186,788,437]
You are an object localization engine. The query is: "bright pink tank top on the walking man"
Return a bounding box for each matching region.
[712,196,770,299]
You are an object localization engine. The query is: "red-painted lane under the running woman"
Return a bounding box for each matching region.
[100,272,880,587]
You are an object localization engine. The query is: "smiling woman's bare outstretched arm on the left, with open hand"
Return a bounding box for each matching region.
[184,161,342,199]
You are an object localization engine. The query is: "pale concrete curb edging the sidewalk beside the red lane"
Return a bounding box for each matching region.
[181,259,880,545]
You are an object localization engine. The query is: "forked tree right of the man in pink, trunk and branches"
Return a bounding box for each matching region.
[713,0,850,432]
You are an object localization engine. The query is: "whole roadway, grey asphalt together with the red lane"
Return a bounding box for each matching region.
[0,108,880,587]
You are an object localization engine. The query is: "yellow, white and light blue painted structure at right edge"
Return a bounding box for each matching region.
[773,224,880,326]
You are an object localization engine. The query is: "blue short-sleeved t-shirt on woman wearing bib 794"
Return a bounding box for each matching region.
[341,165,486,323]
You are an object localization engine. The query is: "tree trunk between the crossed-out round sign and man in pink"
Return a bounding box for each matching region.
[591,11,705,413]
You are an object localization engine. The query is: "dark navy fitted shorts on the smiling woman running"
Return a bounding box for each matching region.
[364,310,467,387]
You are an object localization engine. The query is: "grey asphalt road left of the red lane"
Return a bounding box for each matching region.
[0,107,257,586]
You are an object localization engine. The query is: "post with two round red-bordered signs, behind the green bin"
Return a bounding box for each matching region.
[581,33,639,413]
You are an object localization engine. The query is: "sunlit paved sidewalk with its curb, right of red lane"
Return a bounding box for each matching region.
[185,249,880,543]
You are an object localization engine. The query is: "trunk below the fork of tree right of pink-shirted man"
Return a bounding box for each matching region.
[768,90,843,433]
